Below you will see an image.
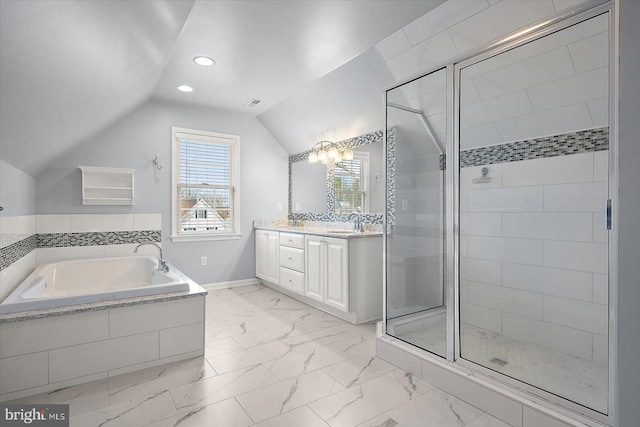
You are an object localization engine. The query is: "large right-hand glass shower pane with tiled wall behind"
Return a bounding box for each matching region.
[457,13,610,413]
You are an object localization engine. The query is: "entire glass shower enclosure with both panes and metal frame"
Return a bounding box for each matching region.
[384,4,615,421]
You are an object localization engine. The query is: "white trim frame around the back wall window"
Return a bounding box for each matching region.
[171,127,242,242]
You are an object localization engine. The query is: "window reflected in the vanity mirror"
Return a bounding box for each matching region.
[333,152,369,214]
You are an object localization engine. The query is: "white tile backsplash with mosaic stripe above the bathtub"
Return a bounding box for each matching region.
[0,214,161,301]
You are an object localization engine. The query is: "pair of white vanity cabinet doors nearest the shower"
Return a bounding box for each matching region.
[305,236,349,311]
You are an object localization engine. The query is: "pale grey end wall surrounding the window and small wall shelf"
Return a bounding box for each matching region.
[35,100,288,284]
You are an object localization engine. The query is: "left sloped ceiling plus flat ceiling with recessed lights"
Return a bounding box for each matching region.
[0,0,443,176]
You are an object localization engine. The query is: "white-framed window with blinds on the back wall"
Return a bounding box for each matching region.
[171,128,240,241]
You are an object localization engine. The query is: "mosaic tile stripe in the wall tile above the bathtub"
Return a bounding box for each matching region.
[0,230,162,271]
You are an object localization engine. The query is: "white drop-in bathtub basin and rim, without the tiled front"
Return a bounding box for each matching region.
[0,257,189,314]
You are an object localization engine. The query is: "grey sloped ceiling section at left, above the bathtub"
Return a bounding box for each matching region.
[0,0,193,176]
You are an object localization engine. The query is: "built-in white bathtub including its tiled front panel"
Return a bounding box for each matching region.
[0,257,207,402]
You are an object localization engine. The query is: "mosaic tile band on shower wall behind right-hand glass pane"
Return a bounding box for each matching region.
[460,126,609,168]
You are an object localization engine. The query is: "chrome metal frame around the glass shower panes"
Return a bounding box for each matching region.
[379,0,619,425]
